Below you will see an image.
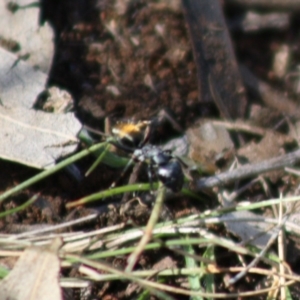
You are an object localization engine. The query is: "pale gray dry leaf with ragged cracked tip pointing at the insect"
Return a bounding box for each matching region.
[0,107,81,168]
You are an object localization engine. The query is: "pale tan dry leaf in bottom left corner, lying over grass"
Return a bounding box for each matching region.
[0,239,62,300]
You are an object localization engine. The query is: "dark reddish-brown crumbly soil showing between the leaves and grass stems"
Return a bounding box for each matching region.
[0,0,299,299]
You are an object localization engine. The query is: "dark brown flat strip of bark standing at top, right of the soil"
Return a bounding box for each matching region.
[182,0,246,119]
